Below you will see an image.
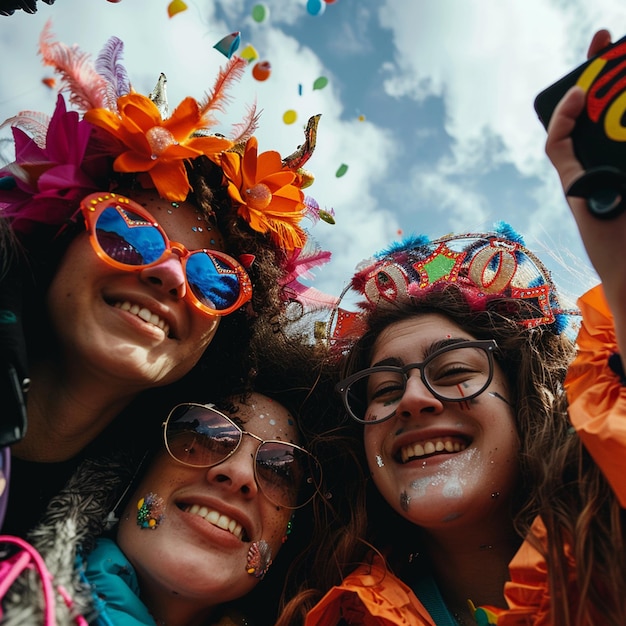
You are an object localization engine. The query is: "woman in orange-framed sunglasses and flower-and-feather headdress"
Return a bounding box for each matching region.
[0,26,330,534]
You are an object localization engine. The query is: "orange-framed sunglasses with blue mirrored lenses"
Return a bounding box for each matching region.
[80,193,252,316]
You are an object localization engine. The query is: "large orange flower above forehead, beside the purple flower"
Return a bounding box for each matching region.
[84,93,232,202]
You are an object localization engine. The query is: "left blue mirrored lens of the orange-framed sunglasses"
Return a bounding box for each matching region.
[96,206,166,266]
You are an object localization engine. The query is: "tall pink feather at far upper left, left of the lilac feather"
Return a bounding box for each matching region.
[39,20,109,111]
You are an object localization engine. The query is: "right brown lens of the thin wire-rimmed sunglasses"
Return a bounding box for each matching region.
[256,442,319,508]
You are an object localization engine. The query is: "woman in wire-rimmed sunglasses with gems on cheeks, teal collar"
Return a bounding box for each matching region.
[3,326,332,626]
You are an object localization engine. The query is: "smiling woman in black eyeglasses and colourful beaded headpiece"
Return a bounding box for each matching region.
[280,225,574,626]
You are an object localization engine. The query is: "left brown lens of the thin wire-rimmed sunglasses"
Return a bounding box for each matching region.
[166,405,241,467]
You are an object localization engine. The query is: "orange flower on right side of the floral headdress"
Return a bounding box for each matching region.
[221,137,306,250]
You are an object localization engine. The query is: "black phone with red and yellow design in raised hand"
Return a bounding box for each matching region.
[534,37,626,172]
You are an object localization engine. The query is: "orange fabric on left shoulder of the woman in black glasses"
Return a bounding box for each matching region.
[305,556,436,626]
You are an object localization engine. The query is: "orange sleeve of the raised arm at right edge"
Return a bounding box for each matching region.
[565,285,626,507]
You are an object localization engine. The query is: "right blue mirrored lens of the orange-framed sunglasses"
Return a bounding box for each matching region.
[186,251,241,311]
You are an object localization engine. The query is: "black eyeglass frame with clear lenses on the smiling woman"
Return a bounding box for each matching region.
[335,339,498,424]
